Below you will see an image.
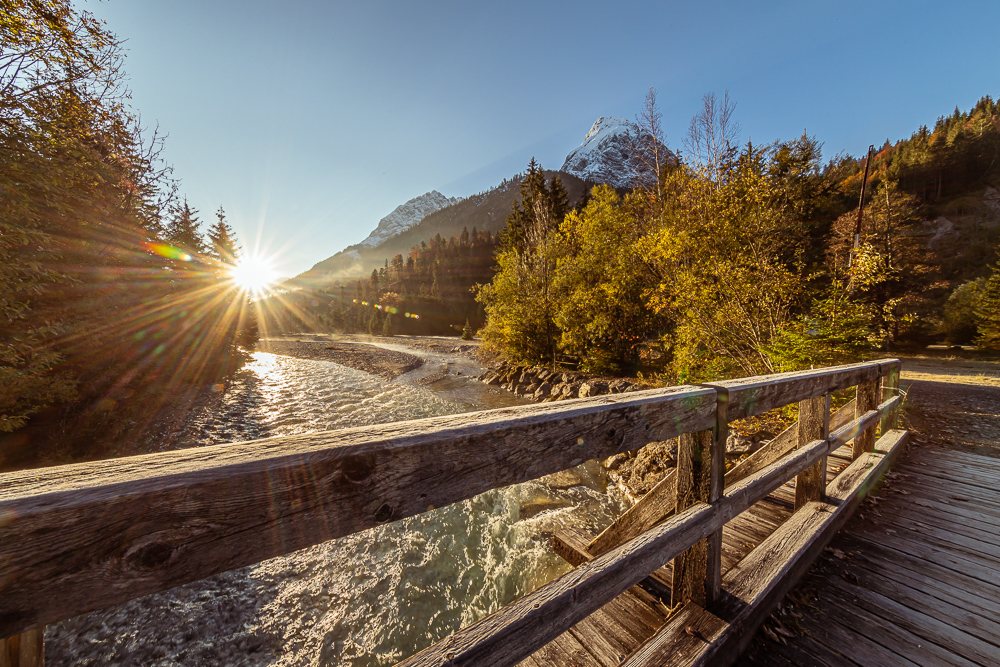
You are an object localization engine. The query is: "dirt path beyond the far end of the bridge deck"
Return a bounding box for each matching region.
[901,357,1000,458]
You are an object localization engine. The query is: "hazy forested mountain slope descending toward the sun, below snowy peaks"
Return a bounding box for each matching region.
[286,171,592,289]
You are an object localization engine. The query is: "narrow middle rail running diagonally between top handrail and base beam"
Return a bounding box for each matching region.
[401,412,844,666]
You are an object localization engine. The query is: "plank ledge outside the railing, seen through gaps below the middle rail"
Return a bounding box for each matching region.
[532,446,851,667]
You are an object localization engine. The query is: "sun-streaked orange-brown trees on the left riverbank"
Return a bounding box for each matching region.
[0,0,254,468]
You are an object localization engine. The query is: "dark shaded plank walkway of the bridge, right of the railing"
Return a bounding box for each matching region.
[739,446,1000,667]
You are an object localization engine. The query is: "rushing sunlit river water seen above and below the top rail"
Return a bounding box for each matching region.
[46,353,624,665]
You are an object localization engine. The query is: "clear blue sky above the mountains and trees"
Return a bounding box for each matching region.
[88,0,1000,276]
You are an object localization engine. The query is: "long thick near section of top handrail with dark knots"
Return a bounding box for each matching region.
[0,387,715,635]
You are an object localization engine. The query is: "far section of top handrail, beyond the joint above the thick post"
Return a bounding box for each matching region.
[702,360,898,420]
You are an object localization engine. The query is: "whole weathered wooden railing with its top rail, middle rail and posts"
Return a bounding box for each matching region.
[0,360,900,665]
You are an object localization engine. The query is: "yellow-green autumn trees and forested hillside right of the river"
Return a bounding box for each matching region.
[478,96,1000,382]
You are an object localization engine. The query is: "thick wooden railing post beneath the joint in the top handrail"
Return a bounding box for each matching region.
[670,429,714,606]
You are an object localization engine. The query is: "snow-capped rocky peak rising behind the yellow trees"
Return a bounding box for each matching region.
[560,116,675,188]
